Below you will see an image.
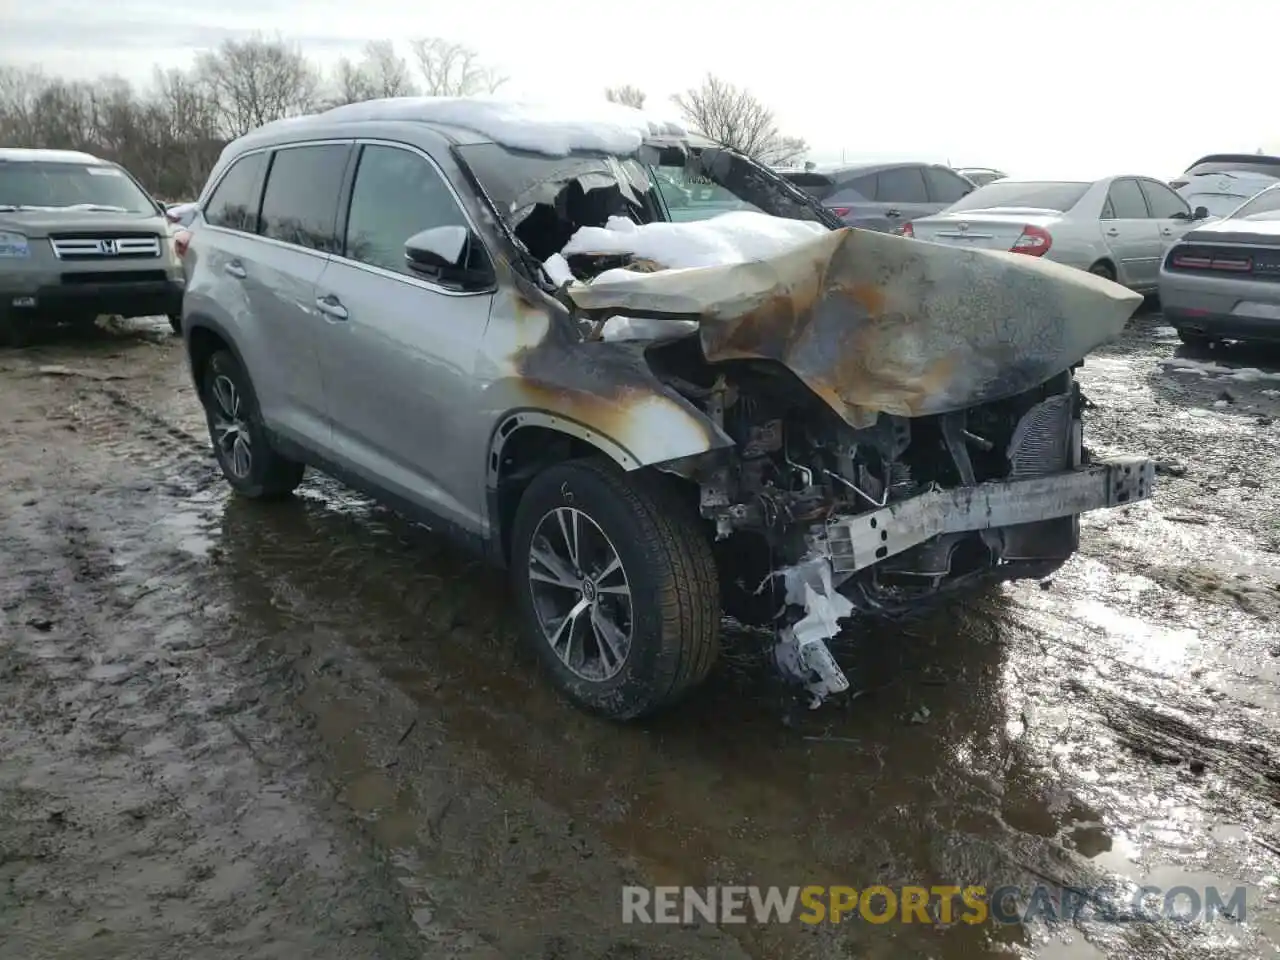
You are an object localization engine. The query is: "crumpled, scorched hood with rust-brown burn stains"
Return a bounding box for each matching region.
[566,229,1142,426]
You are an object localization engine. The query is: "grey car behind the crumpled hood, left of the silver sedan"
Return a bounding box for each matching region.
[783,163,974,233]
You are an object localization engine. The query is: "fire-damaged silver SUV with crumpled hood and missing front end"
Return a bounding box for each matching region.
[183,99,1153,718]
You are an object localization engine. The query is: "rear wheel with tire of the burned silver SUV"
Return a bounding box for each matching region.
[200,349,306,500]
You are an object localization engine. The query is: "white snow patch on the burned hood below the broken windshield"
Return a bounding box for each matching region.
[562,210,828,268]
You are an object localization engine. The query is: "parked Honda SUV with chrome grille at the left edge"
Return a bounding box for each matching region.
[0,150,183,346]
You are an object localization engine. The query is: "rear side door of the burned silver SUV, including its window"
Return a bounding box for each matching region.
[242,141,352,448]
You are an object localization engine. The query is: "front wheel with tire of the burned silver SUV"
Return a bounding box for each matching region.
[511,460,721,721]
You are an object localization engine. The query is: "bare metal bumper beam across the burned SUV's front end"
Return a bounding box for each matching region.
[822,457,1156,575]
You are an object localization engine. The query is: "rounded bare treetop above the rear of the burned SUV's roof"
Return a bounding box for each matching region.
[196,37,319,137]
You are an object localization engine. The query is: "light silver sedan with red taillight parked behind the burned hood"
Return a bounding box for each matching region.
[902,177,1208,293]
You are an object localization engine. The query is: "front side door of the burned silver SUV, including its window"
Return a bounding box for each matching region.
[316,143,493,531]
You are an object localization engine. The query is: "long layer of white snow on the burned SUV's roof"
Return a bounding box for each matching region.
[250,96,687,156]
